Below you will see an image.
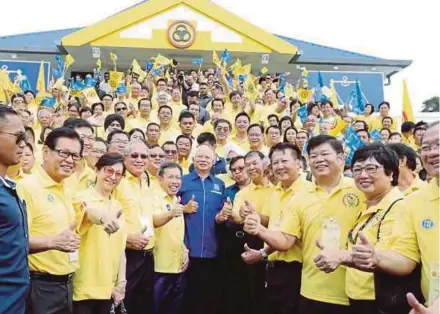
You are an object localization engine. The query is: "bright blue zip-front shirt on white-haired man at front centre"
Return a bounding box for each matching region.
[179,171,225,258]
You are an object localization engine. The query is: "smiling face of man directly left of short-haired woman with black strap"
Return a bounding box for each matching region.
[310,142,344,179]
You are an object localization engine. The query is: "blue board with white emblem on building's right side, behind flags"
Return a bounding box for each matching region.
[308,71,384,109]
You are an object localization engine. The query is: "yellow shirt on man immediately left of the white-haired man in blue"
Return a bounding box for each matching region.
[149,189,185,274]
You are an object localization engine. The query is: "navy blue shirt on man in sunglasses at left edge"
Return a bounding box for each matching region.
[0,178,30,314]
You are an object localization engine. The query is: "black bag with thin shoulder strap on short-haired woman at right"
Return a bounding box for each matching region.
[374,199,425,314]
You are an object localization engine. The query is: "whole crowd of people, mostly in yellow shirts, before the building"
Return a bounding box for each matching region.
[0,60,440,314]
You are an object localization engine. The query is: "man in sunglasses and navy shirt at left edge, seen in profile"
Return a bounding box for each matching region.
[0,106,29,314]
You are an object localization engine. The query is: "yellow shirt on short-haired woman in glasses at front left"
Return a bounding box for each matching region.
[73,187,127,301]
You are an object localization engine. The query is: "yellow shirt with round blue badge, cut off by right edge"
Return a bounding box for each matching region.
[391,178,440,304]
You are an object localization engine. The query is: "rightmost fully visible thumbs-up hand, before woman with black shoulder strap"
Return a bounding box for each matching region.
[352,231,379,272]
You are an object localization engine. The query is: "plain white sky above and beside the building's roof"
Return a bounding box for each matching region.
[0,0,440,114]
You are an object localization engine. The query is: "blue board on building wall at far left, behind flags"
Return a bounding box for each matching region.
[0,60,50,93]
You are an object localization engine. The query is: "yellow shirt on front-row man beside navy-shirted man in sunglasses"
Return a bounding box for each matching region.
[17,167,79,275]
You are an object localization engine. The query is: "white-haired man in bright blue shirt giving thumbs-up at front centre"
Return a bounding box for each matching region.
[179,145,225,314]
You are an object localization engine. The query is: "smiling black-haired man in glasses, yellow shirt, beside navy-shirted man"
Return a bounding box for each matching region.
[17,128,83,314]
